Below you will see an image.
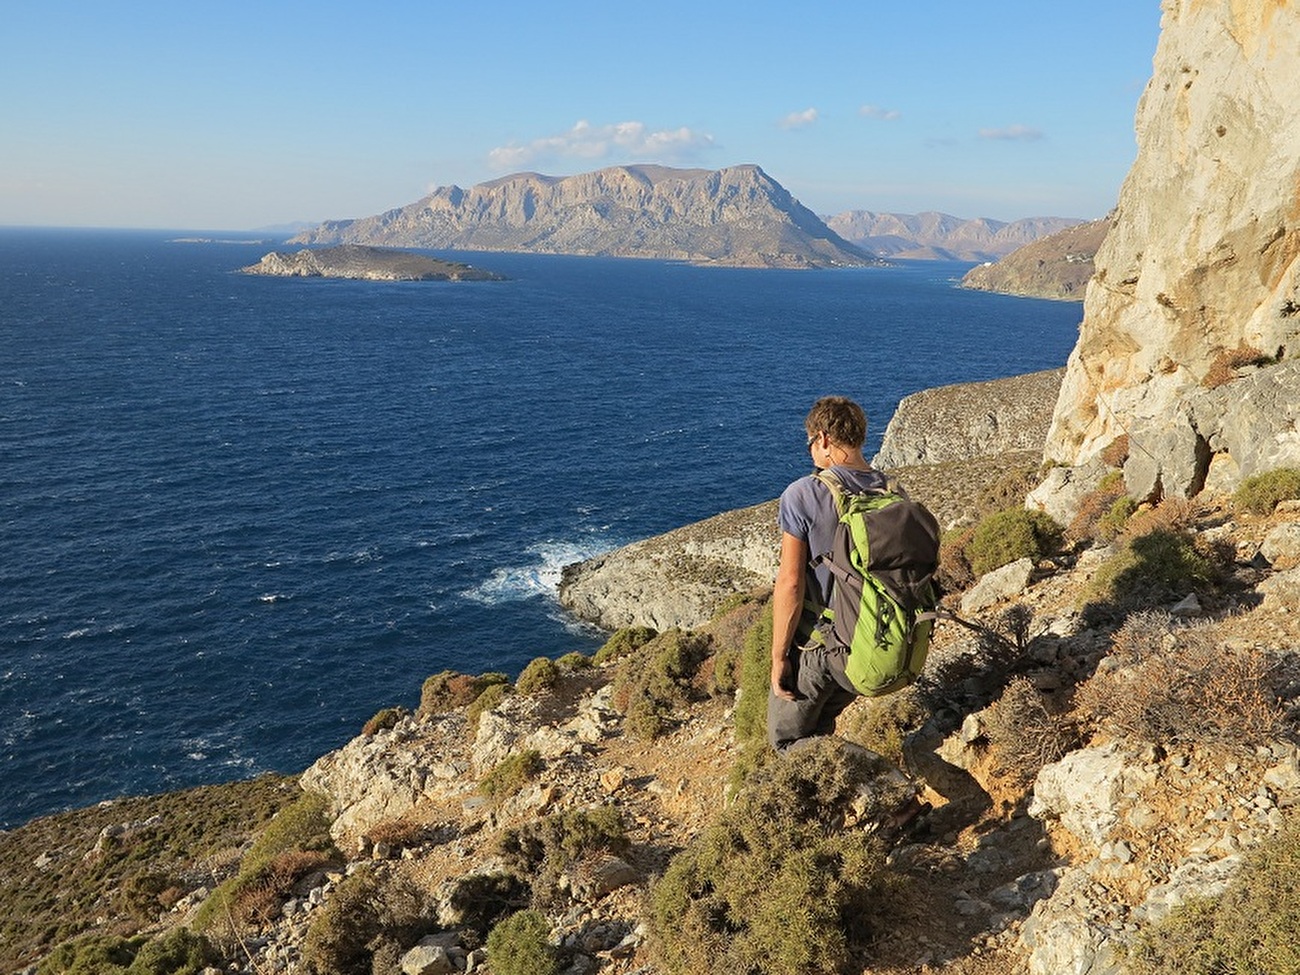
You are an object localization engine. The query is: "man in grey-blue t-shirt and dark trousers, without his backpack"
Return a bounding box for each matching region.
[767,397,885,753]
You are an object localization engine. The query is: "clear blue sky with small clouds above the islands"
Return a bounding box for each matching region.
[0,0,1160,230]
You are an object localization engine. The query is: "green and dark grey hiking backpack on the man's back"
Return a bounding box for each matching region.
[813,471,939,697]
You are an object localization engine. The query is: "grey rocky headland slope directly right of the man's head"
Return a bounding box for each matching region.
[871,369,1065,471]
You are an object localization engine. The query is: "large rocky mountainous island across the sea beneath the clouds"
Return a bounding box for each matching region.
[294,165,874,268]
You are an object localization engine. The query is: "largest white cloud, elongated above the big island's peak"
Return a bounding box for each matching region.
[488,120,714,172]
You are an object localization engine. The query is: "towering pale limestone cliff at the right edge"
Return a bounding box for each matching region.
[1045,0,1300,498]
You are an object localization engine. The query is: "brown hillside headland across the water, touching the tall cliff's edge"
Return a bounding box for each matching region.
[962,217,1110,302]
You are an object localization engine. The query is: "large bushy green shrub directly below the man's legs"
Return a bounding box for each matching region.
[651,740,897,975]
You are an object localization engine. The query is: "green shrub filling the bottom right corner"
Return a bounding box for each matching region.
[1128,823,1300,975]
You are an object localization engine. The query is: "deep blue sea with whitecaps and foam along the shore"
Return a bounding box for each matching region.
[0,229,1082,826]
